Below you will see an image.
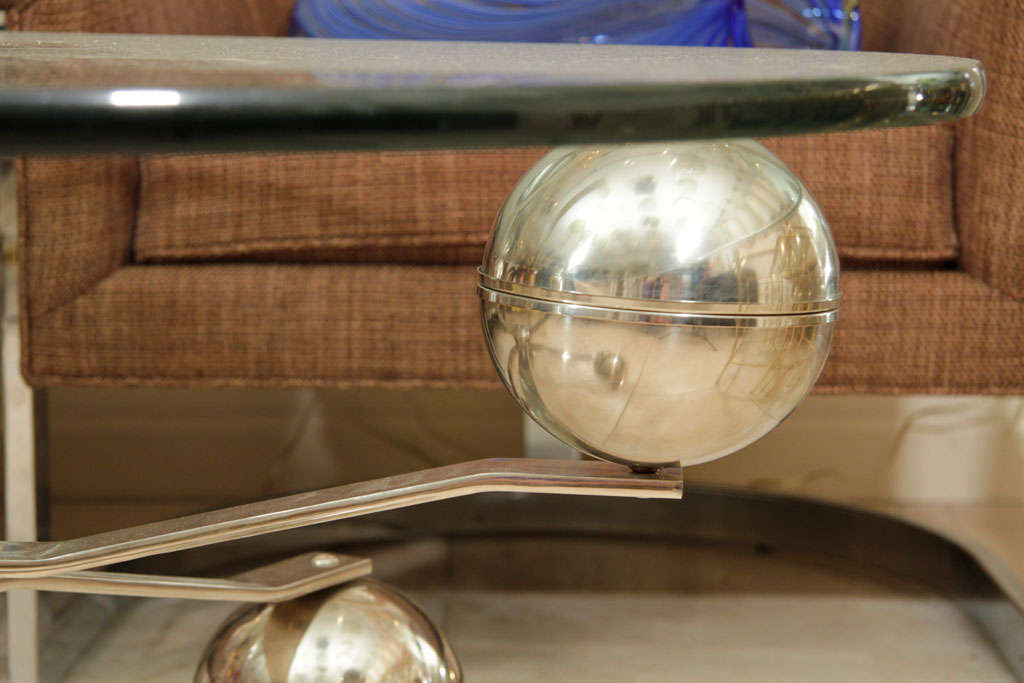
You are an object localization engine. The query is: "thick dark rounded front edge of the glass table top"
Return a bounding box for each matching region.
[0,62,985,155]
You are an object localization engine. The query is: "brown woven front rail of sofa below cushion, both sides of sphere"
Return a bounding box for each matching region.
[22,265,1024,393]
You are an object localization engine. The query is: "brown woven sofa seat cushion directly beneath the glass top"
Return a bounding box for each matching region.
[134,126,956,263]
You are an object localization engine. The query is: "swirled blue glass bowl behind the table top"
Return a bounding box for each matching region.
[292,0,860,50]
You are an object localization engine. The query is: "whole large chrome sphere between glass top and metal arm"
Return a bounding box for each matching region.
[479,140,839,469]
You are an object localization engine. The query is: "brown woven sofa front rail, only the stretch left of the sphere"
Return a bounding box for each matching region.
[29,264,498,387]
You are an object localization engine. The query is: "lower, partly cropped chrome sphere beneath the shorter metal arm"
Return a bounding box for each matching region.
[195,580,462,683]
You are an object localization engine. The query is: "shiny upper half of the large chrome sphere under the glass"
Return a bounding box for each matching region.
[480,140,840,314]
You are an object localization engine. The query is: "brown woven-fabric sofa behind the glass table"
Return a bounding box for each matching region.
[0,0,1024,393]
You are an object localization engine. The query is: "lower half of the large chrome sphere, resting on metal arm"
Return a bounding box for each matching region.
[480,296,836,469]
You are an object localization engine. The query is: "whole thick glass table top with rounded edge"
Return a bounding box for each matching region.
[0,33,984,155]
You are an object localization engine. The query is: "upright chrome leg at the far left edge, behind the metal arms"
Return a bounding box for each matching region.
[0,160,39,683]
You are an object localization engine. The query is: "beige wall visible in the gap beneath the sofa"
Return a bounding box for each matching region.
[39,388,1024,538]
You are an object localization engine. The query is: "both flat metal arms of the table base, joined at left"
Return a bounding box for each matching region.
[0,459,683,602]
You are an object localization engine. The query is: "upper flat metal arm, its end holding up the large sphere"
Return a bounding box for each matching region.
[0,459,683,591]
